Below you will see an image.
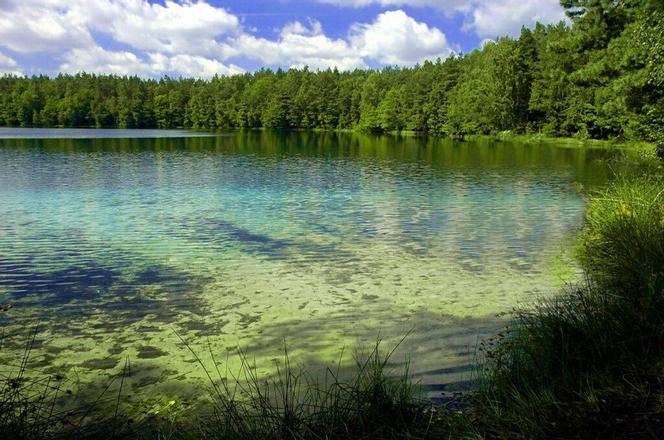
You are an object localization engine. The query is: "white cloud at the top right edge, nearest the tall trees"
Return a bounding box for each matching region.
[318,0,565,37]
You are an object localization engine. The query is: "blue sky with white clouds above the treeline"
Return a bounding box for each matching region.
[0,0,565,78]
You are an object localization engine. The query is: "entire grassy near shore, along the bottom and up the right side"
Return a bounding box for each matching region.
[0,167,664,440]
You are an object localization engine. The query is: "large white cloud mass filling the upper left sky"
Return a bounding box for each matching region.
[0,0,242,77]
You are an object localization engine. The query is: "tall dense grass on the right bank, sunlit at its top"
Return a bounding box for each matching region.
[473,177,664,439]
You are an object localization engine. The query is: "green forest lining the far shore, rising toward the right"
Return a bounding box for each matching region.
[0,0,664,143]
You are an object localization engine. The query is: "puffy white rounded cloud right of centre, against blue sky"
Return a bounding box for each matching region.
[350,10,451,65]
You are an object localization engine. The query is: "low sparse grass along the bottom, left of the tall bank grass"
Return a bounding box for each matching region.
[0,341,441,440]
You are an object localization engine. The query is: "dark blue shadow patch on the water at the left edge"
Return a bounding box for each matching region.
[0,248,211,328]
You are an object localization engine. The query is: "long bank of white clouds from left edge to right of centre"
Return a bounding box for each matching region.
[0,0,460,77]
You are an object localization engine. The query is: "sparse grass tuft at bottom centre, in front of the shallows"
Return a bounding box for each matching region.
[179,341,454,440]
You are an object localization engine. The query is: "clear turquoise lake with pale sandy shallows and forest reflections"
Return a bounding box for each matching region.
[0,129,621,402]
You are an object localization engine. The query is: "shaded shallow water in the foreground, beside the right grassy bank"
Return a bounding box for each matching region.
[223,300,506,394]
